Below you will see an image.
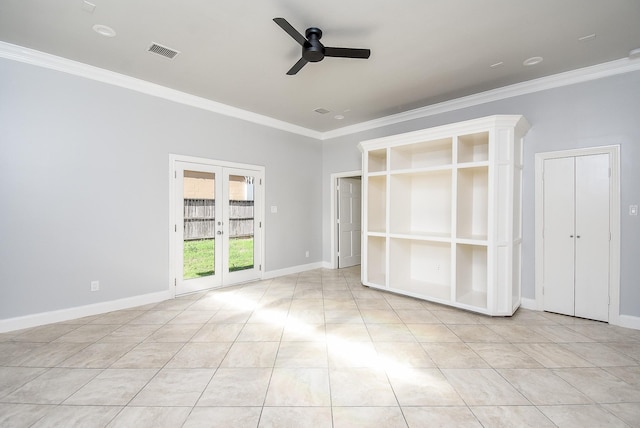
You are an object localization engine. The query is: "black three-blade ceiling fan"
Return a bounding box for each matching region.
[273,18,371,76]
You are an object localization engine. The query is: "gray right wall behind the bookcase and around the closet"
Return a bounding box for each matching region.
[322,72,640,316]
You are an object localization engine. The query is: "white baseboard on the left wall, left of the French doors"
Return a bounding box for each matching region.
[0,290,173,333]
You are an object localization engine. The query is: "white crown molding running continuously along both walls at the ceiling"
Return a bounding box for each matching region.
[0,41,640,141]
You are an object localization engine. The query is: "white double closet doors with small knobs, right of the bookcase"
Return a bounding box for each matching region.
[543,154,611,321]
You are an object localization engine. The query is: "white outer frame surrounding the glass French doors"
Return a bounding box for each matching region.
[168,154,266,297]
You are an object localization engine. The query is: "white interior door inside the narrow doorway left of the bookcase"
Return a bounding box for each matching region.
[337,177,362,268]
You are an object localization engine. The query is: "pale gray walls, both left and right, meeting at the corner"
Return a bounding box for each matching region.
[0,52,640,319]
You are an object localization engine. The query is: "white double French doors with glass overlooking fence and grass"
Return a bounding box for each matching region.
[172,159,264,295]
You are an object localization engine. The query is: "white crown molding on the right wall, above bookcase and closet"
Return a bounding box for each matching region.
[322,58,640,140]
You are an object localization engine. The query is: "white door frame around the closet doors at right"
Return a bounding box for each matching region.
[535,145,620,325]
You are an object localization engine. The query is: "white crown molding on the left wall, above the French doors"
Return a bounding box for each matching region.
[0,41,322,140]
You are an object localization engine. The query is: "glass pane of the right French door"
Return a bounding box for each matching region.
[229,175,254,272]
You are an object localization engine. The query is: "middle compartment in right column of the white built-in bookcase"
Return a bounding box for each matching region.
[456,166,489,240]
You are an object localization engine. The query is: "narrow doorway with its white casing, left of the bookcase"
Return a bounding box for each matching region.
[331,171,362,269]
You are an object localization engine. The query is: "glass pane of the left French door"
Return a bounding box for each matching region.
[182,171,216,279]
